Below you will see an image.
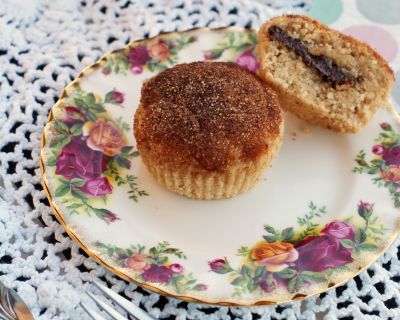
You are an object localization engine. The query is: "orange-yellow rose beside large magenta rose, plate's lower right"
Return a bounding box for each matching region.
[251,241,299,272]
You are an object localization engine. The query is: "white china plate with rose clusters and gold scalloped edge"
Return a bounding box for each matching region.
[41,28,400,306]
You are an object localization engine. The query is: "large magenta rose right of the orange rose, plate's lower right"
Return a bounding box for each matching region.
[296,232,353,272]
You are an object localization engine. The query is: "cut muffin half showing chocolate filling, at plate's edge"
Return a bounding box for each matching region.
[257,15,394,132]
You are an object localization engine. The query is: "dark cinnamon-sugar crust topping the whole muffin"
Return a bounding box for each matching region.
[134,62,282,170]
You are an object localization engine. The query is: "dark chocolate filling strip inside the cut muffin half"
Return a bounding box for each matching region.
[268,26,356,87]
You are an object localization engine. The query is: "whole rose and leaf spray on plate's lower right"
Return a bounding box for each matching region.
[209,201,386,296]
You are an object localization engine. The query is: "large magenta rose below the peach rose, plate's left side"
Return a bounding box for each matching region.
[56,137,106,180]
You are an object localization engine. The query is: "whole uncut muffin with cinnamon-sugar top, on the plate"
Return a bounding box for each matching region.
[134,62,283,199]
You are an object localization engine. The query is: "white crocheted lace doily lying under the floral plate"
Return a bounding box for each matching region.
[0,0,400,320]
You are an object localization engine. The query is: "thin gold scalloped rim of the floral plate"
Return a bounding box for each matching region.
[39,26,400,307]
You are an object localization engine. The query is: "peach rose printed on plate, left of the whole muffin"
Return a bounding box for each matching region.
[82,118,127,157]
